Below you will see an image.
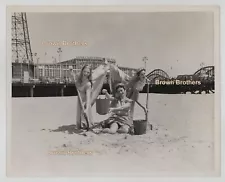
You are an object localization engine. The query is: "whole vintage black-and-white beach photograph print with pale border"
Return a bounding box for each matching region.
[7,6,220,177]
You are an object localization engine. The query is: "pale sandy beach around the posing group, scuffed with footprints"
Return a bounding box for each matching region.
[8,94,215,177]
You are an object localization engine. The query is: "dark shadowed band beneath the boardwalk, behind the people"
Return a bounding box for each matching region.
[12,82,215,97]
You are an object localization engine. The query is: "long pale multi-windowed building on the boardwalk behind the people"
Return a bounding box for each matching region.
[12,57,139,80]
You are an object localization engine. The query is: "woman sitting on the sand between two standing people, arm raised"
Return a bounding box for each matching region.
[102,83,132,134]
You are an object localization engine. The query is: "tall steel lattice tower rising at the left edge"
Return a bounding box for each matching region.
[11,13,34,78]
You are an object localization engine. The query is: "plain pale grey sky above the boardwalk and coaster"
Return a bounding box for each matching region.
[27,12,214,76]
